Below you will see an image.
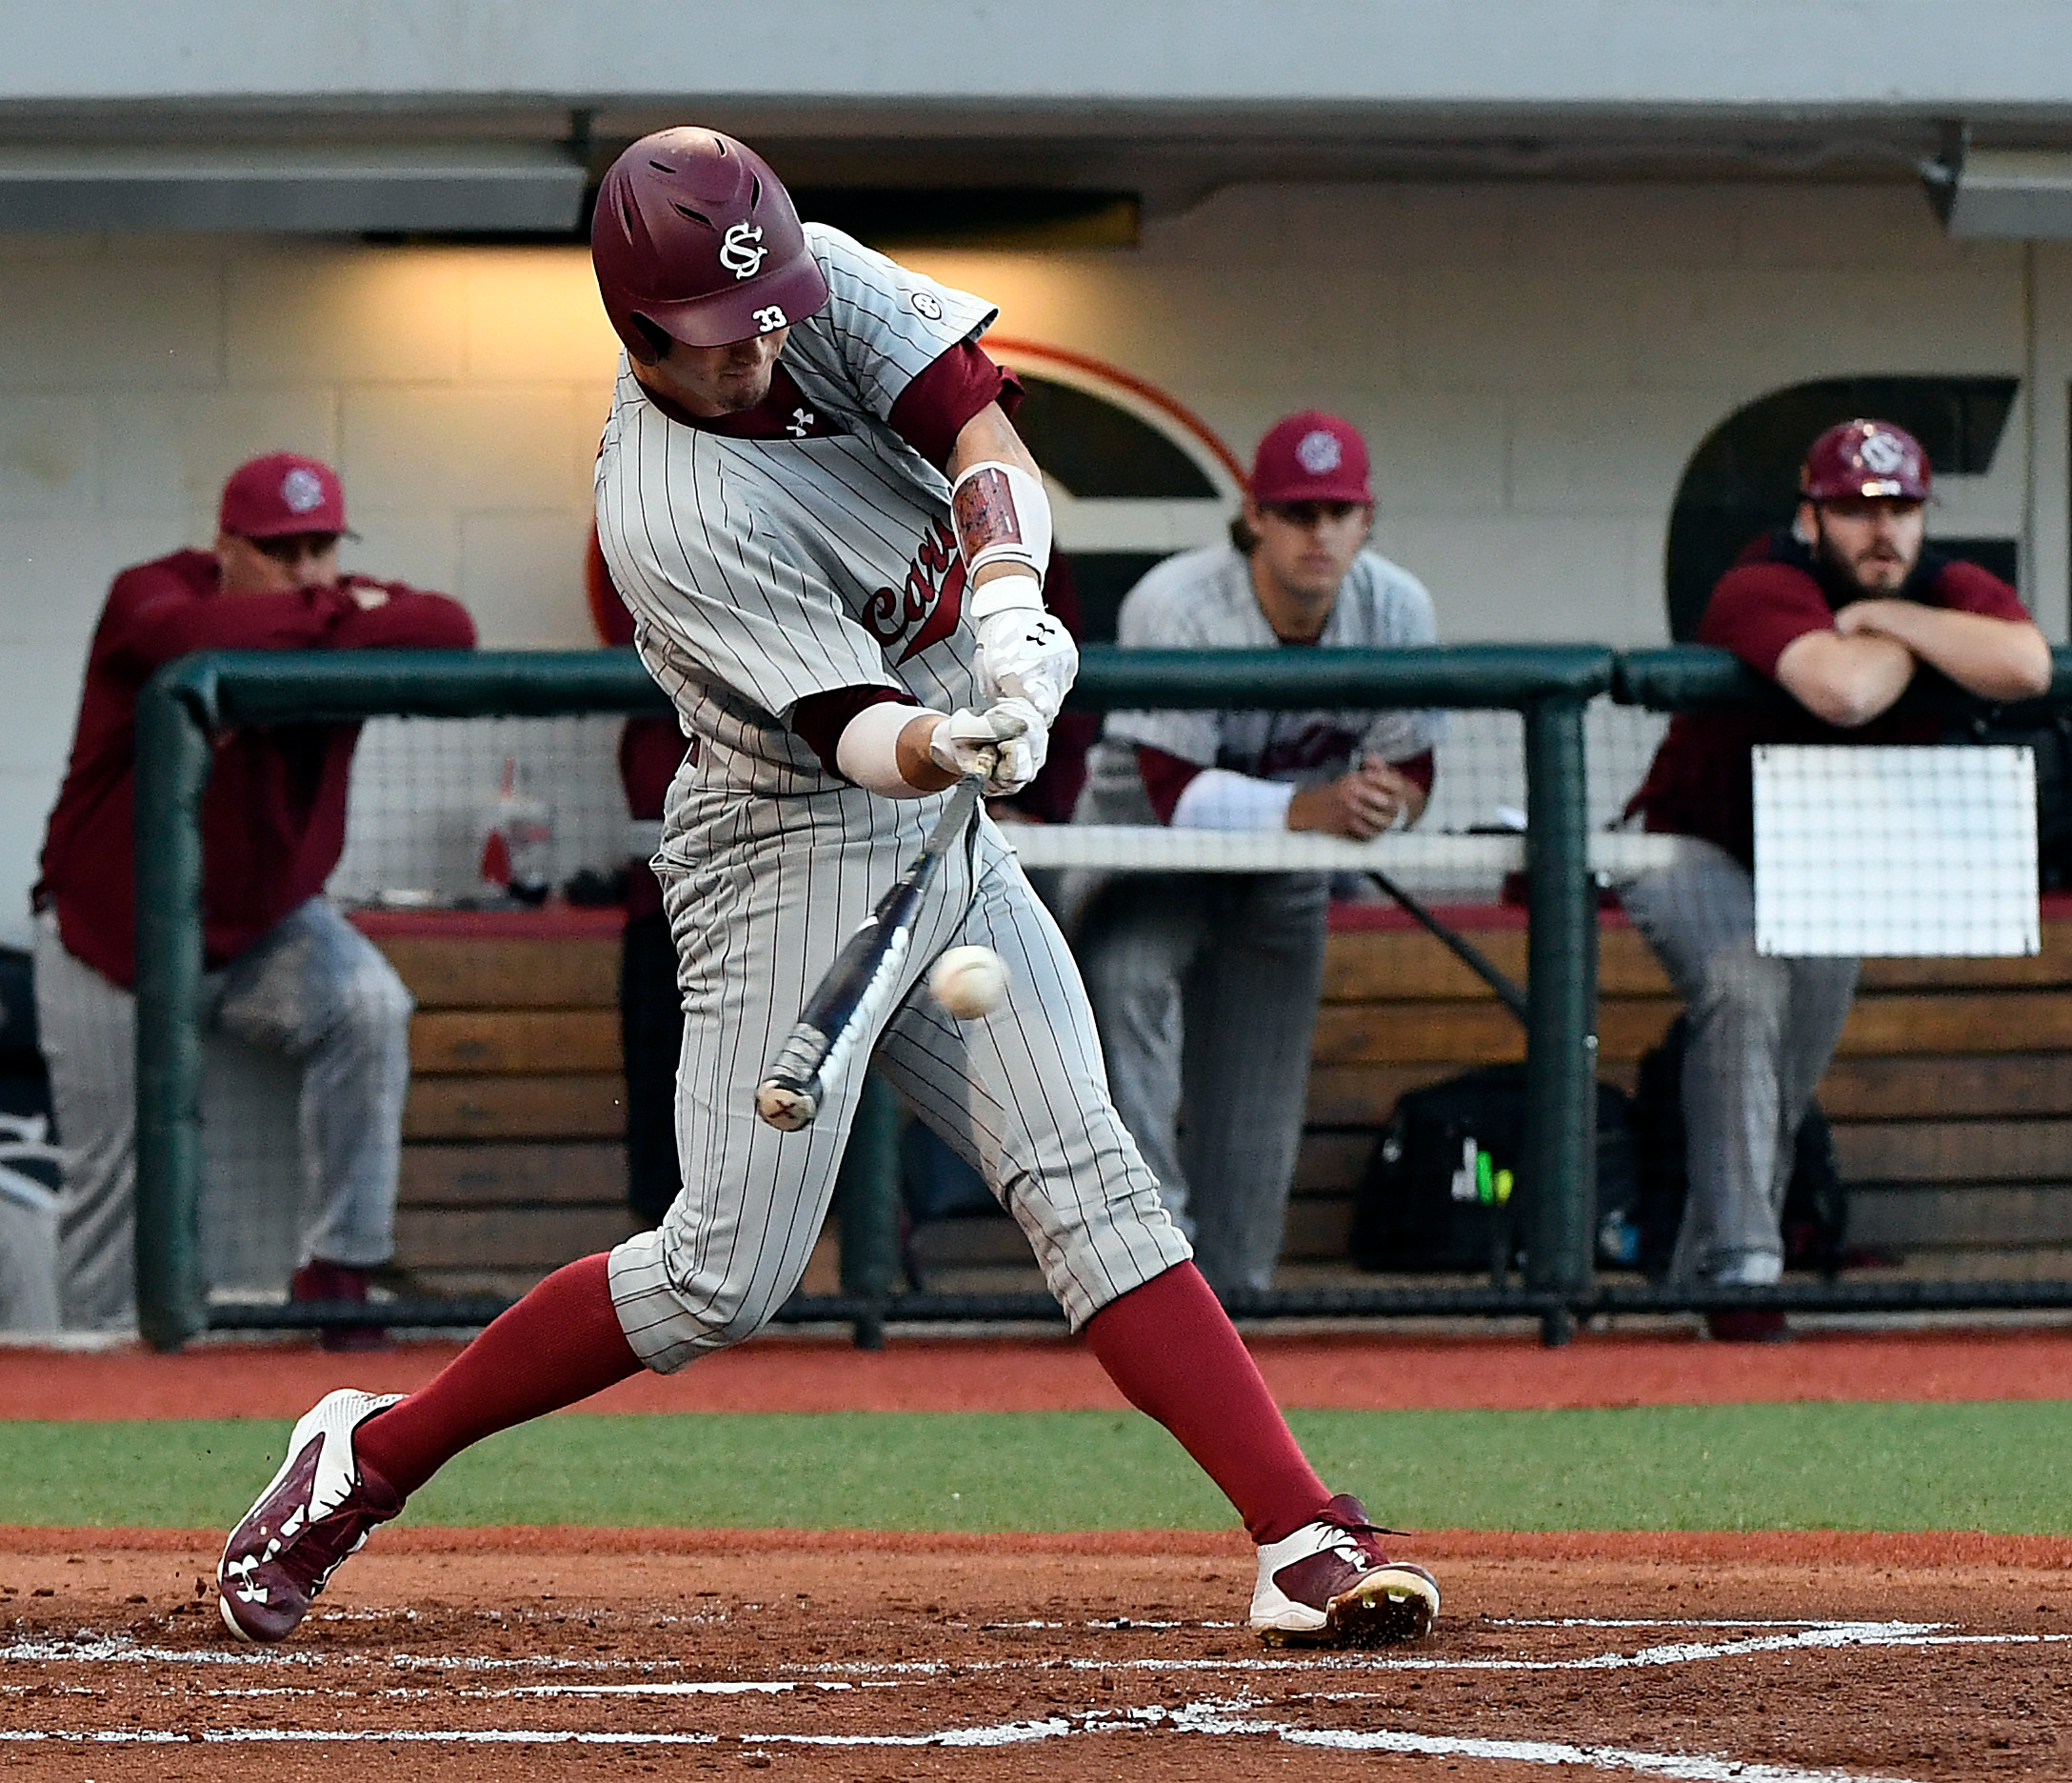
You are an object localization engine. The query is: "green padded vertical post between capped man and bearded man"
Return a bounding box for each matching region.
[1525,694,1598,1346]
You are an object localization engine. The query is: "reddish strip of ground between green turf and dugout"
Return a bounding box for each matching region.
[0,1327,2072,1418]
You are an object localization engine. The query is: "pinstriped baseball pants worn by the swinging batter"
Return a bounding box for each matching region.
[611,788,1189,1372]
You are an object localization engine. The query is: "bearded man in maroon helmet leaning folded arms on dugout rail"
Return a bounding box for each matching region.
[1621,419,2051,1341]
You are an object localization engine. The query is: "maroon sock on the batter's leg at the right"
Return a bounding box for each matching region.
[1084,1263,1330,1542]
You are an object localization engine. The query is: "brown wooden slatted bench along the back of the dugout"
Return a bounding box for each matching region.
[354,900,2072,1292]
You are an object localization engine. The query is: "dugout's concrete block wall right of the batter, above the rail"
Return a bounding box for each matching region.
[916,185,2039,645]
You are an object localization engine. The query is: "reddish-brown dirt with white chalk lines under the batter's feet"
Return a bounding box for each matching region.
[0,1530,2072,1783]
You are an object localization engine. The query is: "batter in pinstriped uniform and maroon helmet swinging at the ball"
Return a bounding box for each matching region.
[217,129,1438,1644]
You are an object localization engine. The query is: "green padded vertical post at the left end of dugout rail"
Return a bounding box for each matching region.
[137,664,213,1350]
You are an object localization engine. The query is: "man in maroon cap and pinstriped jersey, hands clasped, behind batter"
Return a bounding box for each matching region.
[1069,411,1438,1295]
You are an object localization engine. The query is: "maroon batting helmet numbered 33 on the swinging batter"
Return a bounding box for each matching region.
[590,129,827,365]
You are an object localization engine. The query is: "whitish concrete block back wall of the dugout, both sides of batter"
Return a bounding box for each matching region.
[0,185,2072,939]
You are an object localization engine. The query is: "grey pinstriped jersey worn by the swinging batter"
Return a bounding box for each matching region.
[597,224,999,811]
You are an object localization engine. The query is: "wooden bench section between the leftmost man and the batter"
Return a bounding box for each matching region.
[352,906,632,1293]
